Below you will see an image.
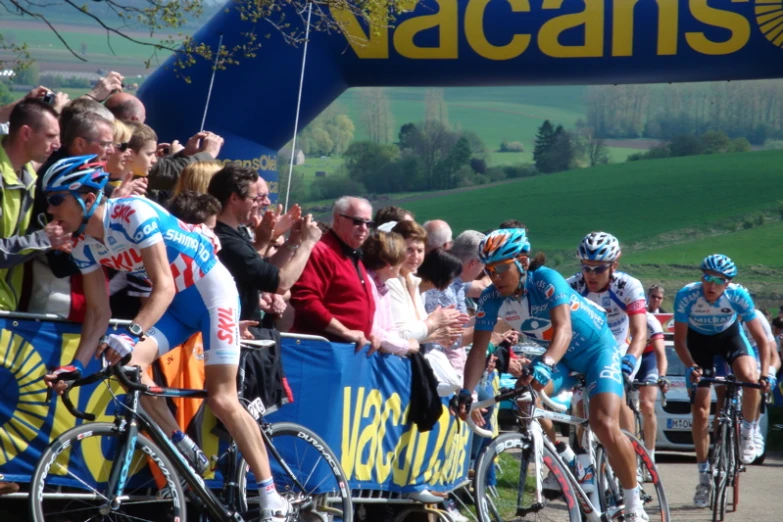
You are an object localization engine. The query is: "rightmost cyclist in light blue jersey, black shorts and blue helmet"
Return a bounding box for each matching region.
[674,254,769,508]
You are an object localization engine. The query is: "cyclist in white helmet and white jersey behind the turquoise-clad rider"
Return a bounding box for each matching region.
[568,232,647,431]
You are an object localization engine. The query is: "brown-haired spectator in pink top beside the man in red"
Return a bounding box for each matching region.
[362,230,419,355]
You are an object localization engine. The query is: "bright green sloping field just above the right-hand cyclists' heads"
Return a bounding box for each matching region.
[402,151,783,250]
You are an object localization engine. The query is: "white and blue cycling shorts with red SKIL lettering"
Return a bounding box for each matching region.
[147,263,240,365]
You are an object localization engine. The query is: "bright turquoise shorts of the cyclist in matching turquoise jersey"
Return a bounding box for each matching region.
[552,336,623,398]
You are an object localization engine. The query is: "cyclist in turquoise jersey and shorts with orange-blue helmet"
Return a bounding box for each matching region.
[453,228,648,521]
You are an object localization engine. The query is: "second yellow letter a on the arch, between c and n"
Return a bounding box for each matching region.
[538,0,604,58]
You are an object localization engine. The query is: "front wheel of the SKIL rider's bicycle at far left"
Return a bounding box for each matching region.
[29,422,187,522]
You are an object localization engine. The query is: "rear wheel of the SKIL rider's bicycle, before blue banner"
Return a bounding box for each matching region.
[236,422,353,522]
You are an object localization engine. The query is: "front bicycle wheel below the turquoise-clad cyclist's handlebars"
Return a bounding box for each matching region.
[473,433,582,522]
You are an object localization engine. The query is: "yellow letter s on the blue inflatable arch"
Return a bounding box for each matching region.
[685,0,750,55]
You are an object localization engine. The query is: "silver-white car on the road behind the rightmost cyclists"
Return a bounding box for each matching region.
[655,334,768,464]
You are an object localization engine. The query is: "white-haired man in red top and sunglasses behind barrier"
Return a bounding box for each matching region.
[291,197,375,348]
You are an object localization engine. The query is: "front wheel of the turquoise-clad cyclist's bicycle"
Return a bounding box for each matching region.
[474,433,582,522]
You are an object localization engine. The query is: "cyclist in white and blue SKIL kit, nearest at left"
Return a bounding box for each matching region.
[43,156,290,522]
